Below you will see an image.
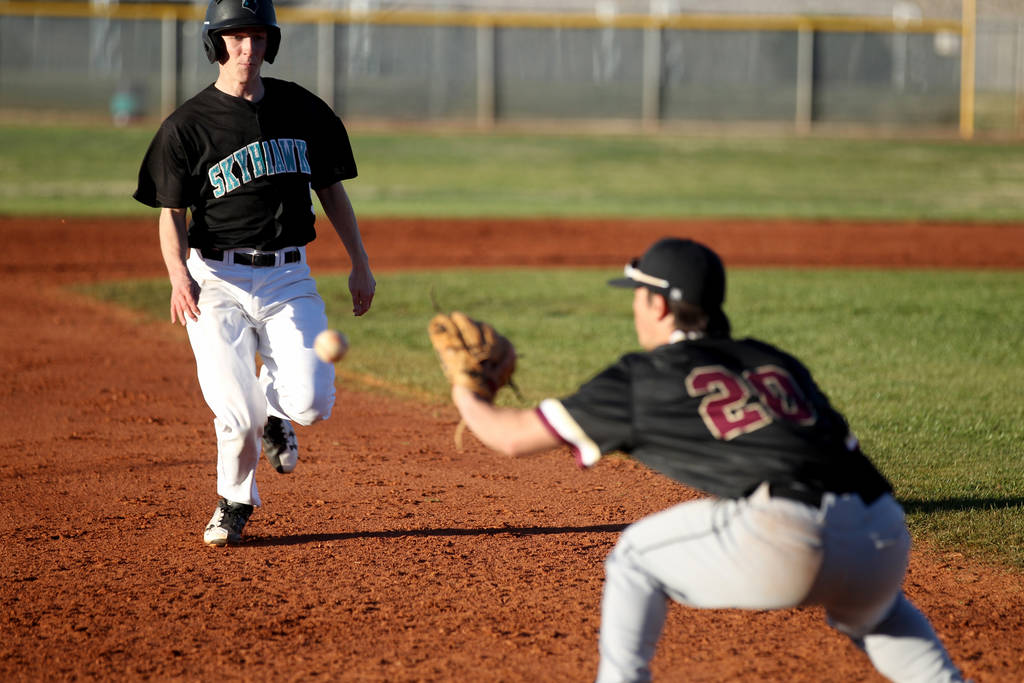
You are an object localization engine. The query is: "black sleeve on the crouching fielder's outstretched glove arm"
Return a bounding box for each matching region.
[561,356,635,454]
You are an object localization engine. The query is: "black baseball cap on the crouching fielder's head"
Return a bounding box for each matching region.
[608,238,725,313]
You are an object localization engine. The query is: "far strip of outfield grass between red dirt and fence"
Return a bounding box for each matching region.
[6,124,1024,221]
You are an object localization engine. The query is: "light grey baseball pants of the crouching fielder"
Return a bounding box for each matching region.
[597,484,963,683]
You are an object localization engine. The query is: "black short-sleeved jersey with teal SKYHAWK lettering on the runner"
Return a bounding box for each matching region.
[134,78,356,250]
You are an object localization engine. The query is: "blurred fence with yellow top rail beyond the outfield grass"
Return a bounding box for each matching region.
[0,0,1024,138]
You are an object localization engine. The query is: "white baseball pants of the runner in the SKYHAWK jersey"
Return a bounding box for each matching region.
[180,248,335,505]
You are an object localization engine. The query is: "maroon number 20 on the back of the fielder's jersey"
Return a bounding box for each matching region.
[686,366,817,441]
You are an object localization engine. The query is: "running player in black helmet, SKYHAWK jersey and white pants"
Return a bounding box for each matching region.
[134,0,376,546]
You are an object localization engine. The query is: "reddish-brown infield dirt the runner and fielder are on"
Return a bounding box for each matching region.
[0,216,1024,683]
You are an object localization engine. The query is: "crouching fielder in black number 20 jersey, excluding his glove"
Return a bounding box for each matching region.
[444,239,962,682]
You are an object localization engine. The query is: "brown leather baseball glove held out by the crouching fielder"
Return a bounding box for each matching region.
[427,310,516,402]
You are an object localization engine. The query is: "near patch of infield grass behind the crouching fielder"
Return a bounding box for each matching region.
[75,268,1024,569]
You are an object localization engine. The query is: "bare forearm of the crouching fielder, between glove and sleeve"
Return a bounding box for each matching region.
[452,386,559,456]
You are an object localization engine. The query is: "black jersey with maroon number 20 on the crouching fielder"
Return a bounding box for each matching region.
[541,338,891,498]
